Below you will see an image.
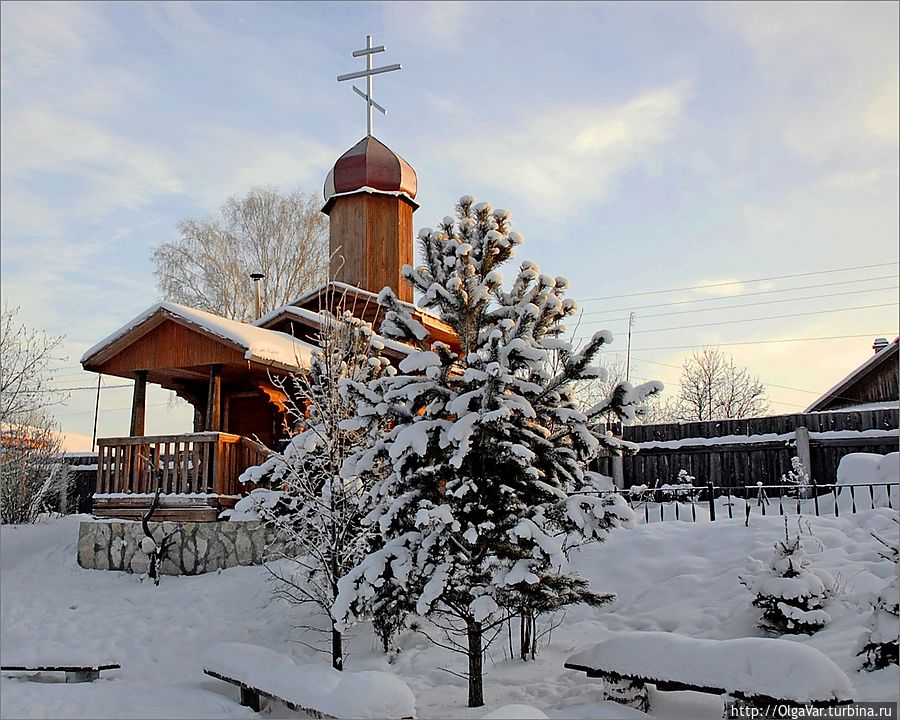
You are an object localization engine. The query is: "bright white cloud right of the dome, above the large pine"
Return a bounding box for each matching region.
[435,83,686,212]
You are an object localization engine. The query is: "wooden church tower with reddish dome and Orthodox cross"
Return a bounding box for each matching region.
[322,35,418,302]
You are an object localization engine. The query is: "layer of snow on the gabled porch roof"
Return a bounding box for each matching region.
[81,302,316,369]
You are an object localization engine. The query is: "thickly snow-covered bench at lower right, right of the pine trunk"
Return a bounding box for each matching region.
[565,632,854,712]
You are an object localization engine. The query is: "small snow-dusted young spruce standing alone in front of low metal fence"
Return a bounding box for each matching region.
[738,517,834,635]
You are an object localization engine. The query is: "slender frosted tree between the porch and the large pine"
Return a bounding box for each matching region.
[241,311,393,670]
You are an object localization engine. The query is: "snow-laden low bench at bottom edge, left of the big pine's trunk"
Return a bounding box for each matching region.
[203,643,415,719]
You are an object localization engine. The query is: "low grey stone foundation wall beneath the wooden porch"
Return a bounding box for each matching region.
[78,520,285,575]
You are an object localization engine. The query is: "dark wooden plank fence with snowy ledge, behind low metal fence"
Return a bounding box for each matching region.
[597,408,900,488]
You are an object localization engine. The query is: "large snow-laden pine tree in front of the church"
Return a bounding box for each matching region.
[334,196,662,707]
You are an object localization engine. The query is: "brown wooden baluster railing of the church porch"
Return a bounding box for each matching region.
[96,432,270,496]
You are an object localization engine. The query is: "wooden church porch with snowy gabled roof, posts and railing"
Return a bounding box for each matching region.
[82,303,313,521]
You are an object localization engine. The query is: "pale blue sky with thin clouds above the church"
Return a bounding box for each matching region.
[0,1,900,449]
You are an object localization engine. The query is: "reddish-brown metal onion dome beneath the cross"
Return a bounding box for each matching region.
[322,136,418,212]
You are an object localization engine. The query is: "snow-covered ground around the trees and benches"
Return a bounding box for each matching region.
[0,508,900,718]
